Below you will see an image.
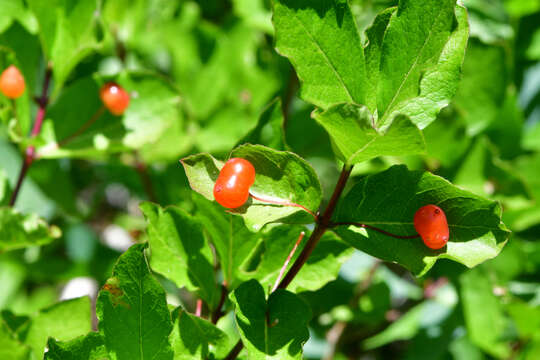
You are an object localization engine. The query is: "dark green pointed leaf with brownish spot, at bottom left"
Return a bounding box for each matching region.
[96,244,173,360]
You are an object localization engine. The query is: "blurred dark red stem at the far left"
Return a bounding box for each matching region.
[9,67,52,206]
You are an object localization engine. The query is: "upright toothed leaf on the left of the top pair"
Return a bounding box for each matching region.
[273,0,366,108]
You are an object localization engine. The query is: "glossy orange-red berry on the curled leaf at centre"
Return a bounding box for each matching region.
[214,158,255,209]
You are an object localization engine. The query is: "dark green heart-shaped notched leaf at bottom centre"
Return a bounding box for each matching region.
[230,280,311,360]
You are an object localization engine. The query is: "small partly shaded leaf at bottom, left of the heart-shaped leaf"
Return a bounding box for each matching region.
[169,308,230,360]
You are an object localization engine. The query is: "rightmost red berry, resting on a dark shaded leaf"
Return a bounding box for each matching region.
[414,205,449,249]
